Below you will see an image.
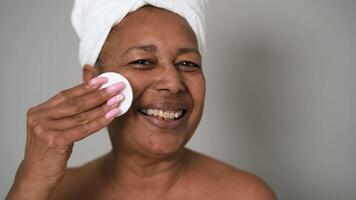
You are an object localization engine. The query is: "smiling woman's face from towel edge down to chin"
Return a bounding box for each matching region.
[100,6,205,155]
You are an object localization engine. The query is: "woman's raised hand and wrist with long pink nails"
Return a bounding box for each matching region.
[7,77,124,199]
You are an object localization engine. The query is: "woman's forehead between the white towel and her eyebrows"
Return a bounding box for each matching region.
[104,6,198,53]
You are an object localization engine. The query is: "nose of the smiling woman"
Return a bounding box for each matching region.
[154,65,186,94]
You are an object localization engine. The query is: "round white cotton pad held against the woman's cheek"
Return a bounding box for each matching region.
[99,72,133,116]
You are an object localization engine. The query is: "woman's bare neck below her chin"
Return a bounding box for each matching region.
[107,146,186,192]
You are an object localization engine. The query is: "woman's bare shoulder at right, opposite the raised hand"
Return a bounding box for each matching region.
[186,151,277,200]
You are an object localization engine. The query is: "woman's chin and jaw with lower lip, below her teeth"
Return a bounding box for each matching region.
[109,111,194,158]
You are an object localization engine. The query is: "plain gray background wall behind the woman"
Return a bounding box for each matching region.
[0,0,356,200]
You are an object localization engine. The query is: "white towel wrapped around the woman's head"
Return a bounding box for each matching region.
[72,0,208,66]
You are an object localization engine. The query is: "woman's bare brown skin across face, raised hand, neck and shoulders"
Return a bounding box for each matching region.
[8,7,275,200]
